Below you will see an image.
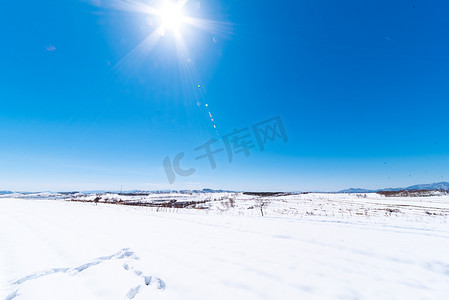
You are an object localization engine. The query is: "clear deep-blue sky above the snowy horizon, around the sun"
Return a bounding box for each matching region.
[0,0,449,191]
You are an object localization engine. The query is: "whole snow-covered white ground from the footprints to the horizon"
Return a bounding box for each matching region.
[0,193,449,300]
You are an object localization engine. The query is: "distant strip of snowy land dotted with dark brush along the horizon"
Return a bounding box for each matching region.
[64,192,449,220]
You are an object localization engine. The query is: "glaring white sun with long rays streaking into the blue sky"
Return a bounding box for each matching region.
[98,0,233,136]
